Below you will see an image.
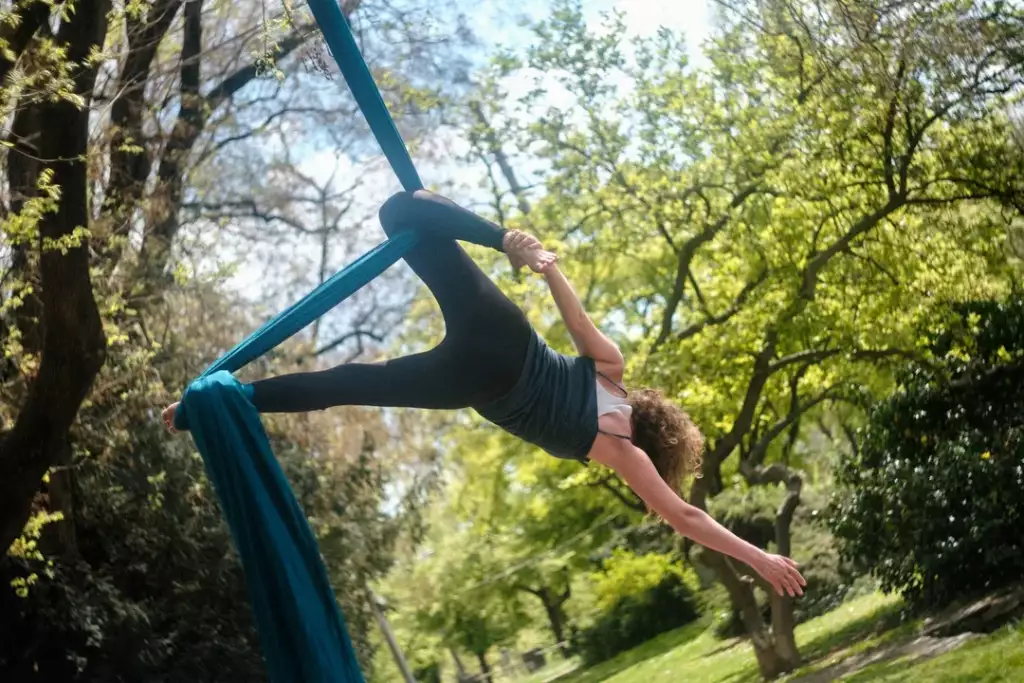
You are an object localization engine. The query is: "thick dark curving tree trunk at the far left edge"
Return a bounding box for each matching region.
[0,0,109,549]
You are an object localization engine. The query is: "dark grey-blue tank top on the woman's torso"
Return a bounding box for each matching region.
[475,331,598,463]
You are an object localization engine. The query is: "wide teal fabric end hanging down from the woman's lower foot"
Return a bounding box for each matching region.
[176,371,364,683]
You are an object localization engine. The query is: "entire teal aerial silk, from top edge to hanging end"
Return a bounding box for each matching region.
[174,0,423,683]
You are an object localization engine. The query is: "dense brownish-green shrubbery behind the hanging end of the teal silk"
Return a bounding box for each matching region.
[0,281,408,683]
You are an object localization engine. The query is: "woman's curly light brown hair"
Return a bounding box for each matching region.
[627,389,705,492]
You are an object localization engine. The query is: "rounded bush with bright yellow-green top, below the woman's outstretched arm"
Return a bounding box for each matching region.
[577,551,697,666]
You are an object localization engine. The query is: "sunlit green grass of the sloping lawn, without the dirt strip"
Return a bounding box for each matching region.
[532,594,1024,683]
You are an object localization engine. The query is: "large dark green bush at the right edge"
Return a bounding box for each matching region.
[829,299,1024,607]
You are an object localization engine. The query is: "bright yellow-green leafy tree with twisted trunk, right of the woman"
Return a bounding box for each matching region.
[456,1,1024,677]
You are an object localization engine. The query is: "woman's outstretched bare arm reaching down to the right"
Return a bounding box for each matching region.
[591,438,807,596]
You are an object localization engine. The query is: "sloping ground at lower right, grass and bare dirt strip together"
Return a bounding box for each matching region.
[535,588,1024,683]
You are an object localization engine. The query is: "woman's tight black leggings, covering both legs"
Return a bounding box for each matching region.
[253,191,532,413]
